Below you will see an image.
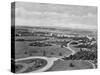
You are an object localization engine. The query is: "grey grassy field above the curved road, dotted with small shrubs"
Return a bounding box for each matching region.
[15,42,71,58]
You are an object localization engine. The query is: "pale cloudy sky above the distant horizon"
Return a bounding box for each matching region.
[12,2,97,29]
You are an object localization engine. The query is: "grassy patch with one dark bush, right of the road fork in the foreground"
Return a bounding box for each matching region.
[48,60,93,71]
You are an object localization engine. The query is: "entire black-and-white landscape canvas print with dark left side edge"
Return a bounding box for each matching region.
[11,2,98,73]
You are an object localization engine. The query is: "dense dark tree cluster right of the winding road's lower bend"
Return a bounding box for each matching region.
[64,51,97,60]
